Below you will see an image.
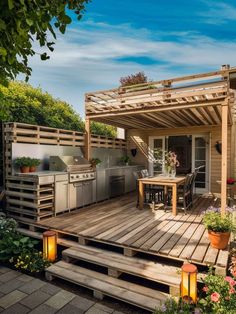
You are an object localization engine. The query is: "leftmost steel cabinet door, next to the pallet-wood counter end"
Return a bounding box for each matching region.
[55,181,69,213]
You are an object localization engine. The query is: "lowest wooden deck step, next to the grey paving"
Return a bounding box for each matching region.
[46,261,168,311]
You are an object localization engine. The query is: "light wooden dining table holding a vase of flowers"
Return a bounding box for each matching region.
[138,176,185,216]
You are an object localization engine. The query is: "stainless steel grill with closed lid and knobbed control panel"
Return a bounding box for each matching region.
[49,156,96,183]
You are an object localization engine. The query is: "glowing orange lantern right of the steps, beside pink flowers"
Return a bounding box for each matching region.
[180,264,197,303]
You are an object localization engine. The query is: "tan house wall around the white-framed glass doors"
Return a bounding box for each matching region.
[126,126,231,193]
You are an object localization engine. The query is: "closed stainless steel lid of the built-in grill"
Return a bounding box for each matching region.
[49,156,92,172]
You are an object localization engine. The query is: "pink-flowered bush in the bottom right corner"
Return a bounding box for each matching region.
[199,273,236,314]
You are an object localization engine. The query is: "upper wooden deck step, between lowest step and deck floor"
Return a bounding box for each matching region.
[62,245,181,294]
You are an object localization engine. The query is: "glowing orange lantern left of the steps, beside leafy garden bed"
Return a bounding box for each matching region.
[43,230,57,262]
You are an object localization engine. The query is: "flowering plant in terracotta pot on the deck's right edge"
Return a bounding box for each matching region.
[203,207,235,250]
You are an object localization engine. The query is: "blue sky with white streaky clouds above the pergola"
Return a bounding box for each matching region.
[25,0,236,116]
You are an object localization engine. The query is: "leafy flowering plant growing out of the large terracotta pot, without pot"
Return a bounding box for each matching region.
[203,206,236,232]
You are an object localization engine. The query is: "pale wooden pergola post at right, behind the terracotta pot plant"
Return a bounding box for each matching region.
[221,102,228,215]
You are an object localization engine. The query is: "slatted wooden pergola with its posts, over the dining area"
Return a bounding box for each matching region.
[85,68,236,214]
